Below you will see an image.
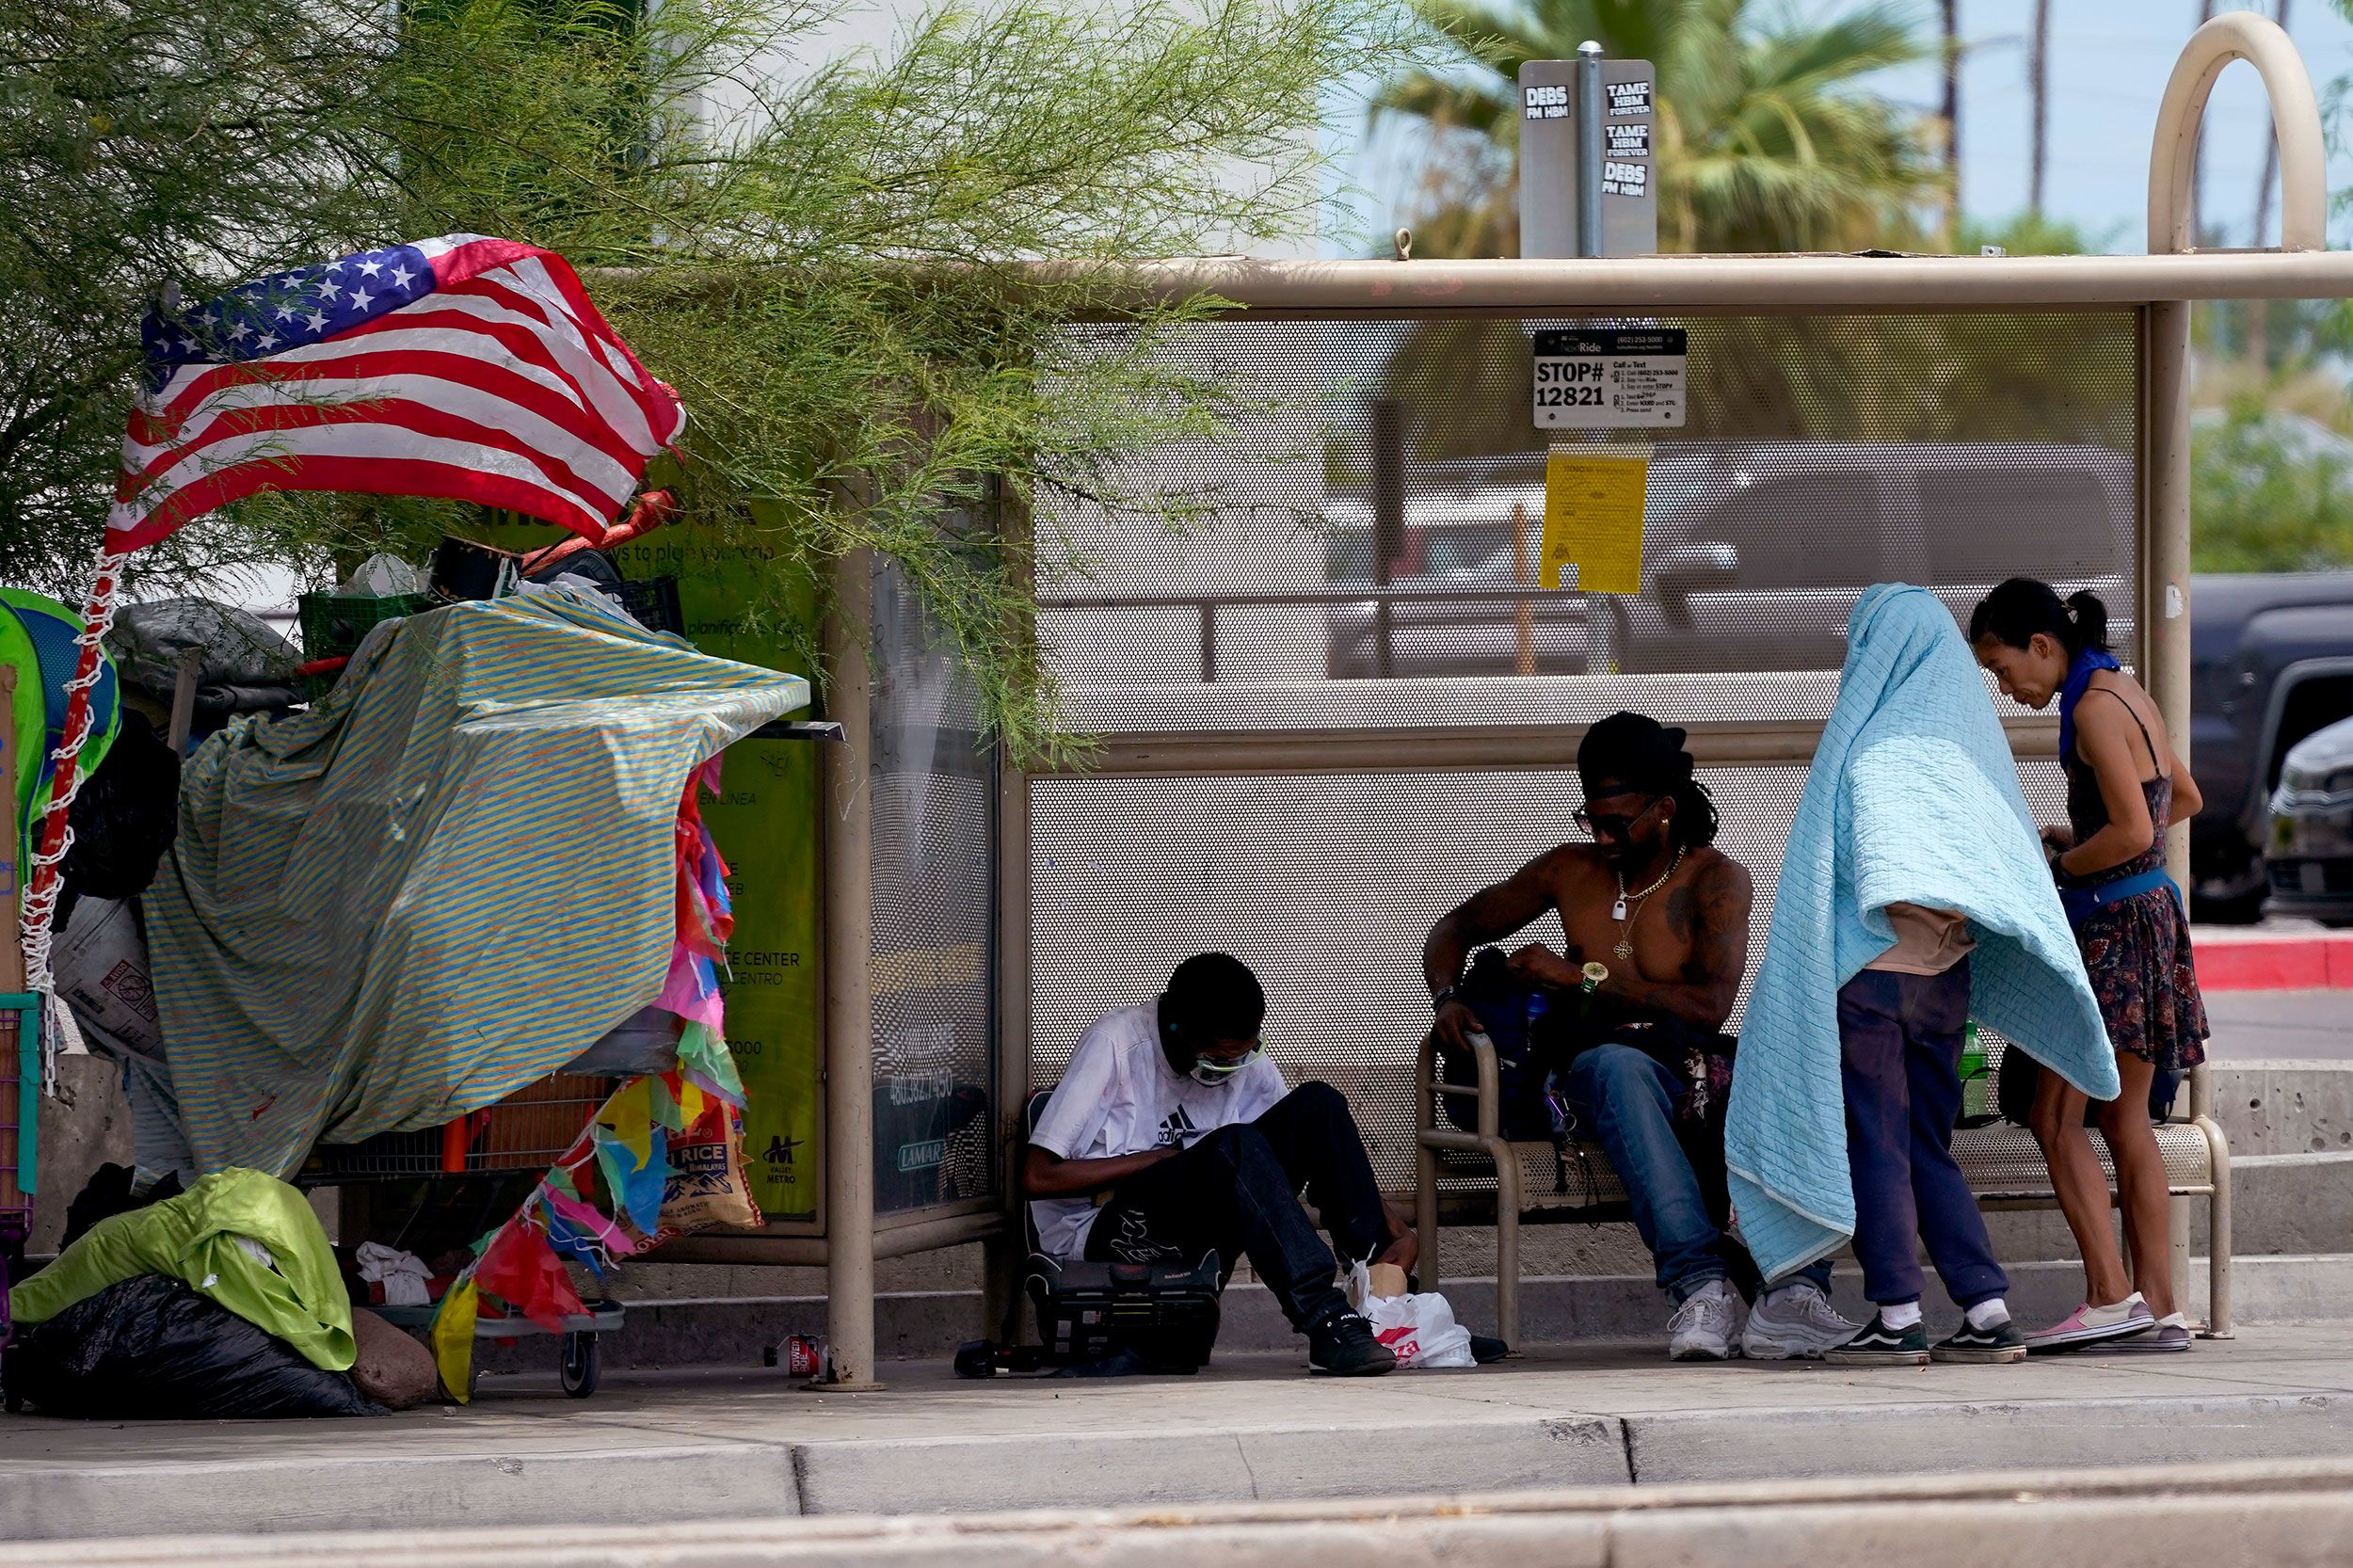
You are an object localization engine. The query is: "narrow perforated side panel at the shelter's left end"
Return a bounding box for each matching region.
[873,557,998,1212]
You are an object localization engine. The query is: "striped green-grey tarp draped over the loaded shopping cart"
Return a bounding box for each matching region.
[146,596,809,1175]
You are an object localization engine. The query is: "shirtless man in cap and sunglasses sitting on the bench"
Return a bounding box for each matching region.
[1421,713,1854,1361]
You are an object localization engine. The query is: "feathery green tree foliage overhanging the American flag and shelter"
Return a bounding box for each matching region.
[0,0,1419,753]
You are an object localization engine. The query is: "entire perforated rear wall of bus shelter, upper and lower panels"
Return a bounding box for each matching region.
[1031,311,2141,1189]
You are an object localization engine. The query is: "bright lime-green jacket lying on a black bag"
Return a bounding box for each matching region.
[8,1170,356,1372]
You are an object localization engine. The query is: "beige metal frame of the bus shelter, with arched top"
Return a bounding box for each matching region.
[671,12,2353,1386]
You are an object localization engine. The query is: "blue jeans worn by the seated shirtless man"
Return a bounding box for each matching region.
[1565,1046,1831,1304]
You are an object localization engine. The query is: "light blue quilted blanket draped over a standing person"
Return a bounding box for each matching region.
[1725,586,2118,1278]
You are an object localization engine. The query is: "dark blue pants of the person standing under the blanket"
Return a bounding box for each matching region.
[1838,958,2009,1306]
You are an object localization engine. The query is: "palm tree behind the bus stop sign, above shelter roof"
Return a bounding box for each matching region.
[1372,0,1946,254]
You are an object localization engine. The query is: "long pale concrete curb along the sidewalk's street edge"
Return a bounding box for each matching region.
[0,1391,2353,1534]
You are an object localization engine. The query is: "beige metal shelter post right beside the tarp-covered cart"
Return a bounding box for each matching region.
[824,549,880,1389]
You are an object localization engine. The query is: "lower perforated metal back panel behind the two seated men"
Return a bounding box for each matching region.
[1031,760,2066,1192]
